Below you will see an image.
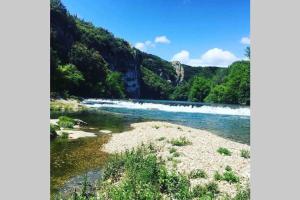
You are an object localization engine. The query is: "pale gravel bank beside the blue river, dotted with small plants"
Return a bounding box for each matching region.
[102,122,250,197]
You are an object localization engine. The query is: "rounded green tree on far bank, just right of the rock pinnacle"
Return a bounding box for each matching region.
[188,76,211,102]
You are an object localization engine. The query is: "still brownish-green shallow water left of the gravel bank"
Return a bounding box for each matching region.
[50,109,142,195]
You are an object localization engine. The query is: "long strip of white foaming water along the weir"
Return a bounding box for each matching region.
[82,99,250,116]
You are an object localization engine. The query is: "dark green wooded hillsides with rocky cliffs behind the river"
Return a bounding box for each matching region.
[50,0,250,105]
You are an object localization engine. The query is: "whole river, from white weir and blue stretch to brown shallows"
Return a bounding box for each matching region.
[51,99,250,196]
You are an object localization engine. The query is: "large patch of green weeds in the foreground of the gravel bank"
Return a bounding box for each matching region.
[53,146,250,200]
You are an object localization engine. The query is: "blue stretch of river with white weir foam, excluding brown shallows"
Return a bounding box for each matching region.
[82,99,250,144]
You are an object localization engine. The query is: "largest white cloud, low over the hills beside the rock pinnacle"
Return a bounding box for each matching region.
[171,48,239,67]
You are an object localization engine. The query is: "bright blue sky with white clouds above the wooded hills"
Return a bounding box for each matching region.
[62,0,250,67]
